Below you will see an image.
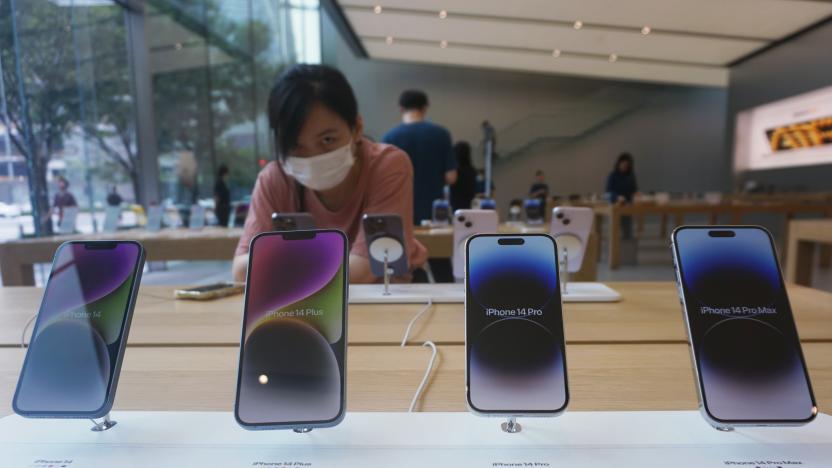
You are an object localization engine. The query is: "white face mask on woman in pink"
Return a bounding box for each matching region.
[282,140,355,190]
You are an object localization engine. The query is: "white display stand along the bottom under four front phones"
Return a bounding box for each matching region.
[0,411,832,468]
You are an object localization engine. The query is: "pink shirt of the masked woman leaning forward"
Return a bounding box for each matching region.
[236,138,427,268]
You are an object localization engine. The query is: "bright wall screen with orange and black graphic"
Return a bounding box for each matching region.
[734,86,832,172]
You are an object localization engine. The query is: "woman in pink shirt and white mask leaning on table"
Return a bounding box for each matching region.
[233,65,427,283]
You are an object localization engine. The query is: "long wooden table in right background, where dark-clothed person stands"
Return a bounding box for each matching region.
[593,200,832,270]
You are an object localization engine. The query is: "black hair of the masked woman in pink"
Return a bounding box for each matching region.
[268,64,358,159]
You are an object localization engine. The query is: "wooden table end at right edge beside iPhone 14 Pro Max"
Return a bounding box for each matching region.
[786,219,832,286]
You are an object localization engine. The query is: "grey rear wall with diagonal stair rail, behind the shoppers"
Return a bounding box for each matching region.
[322,15,731,212]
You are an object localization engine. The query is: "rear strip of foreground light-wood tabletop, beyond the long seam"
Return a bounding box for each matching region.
[0,282,832,347]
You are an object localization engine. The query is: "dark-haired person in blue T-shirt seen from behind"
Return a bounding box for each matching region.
[382,90,457,225]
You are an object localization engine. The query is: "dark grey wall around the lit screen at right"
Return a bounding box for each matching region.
[728,21,832,190]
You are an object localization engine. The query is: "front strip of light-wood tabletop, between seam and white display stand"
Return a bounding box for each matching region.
[0,343,832,416]
